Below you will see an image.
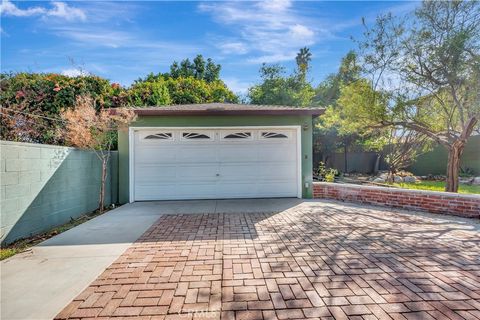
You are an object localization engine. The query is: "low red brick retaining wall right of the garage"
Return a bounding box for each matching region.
[313,182,480,218]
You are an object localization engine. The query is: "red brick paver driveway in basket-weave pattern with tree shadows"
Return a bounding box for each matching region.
[57,202,480,320]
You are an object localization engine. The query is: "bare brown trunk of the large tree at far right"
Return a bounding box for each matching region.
[445,117,478,192]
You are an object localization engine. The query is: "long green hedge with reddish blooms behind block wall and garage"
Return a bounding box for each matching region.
[0,73,238,145]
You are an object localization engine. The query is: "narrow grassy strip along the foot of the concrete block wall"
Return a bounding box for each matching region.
[0,209,109,260]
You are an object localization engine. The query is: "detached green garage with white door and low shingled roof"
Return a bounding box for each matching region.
[118,103,322,203]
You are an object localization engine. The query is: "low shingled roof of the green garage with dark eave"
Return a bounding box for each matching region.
[128,103,324,116]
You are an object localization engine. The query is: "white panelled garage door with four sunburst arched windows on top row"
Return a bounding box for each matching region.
[132,128,300,201]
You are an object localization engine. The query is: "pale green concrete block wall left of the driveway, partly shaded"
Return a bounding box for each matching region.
[0,141,118,245]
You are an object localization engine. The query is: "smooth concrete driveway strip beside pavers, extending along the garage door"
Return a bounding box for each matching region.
[0,199,300,319]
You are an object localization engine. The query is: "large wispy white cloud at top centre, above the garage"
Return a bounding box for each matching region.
[198,0,318,63]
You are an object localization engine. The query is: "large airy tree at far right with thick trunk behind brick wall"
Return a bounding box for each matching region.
[355,1,480,192]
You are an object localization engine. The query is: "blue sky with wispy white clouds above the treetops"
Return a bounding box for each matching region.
[0,0,418,92]
